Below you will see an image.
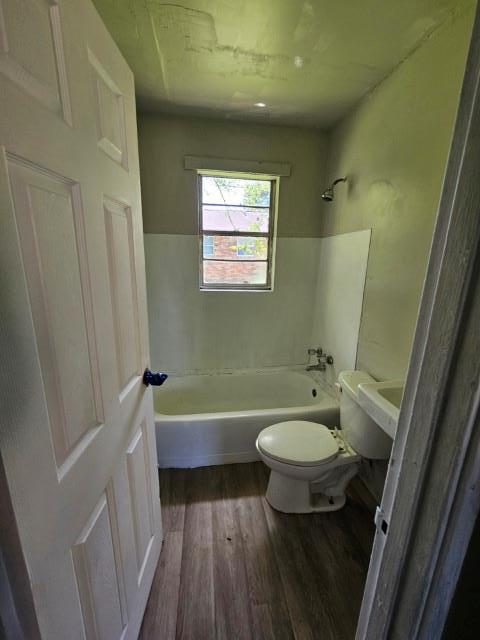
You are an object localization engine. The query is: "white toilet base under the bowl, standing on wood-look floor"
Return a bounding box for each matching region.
[266,469,346,513]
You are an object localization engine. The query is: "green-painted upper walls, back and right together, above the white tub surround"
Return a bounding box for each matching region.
[139,0,476,388]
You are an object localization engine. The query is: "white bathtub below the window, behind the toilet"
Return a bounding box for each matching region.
[154,371,339,468]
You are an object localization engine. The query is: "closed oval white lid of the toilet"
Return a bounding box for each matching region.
[257,420,338,467]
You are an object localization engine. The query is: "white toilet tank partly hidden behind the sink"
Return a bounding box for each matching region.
[338,371,393,460]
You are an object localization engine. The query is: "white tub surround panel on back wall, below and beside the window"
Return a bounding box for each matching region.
[145,234,319,374]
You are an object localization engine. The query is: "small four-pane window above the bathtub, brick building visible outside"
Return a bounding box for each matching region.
[198,172,278,290]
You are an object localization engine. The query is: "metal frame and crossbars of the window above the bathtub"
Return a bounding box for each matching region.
[197,169,280,292]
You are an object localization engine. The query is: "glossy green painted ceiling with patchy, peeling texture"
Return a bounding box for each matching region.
[94,0,462,129]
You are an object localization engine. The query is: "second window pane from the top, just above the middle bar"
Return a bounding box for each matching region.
[202,205,270,233]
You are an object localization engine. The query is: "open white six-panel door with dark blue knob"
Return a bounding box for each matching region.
[0,0,161,640]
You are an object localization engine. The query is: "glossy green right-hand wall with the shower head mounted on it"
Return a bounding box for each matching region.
[322,1,475,379]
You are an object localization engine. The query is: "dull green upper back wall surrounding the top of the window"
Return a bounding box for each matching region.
[138,115,327,238]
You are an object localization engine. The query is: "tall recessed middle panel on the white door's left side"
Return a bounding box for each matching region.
[8,158,103,466]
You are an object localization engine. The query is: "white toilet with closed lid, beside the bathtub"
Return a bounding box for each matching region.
[256,371,393,513]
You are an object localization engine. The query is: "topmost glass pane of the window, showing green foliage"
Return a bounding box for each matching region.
[202,176,271,207]
